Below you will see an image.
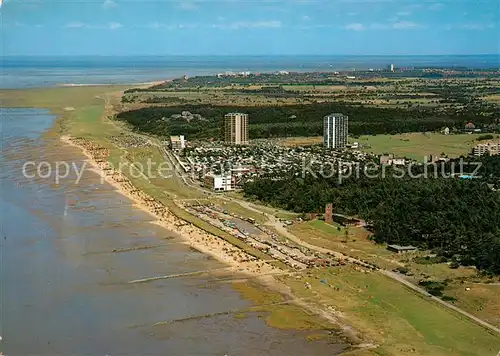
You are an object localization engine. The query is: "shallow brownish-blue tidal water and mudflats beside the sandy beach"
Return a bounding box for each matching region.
[0,109,343,356]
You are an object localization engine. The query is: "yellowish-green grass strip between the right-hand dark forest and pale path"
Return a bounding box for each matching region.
[290,220,500,332]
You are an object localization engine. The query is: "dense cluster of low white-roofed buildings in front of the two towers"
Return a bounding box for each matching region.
[176,141,371,191]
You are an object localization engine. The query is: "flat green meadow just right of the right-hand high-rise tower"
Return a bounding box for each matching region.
[352,133,480,161]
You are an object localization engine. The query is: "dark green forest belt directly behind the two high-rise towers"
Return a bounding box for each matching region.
[117,102,491,140]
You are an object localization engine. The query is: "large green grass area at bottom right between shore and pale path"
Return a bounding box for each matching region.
[280,267,500,356]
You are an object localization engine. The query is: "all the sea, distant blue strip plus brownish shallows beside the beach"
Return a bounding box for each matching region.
[0,56,499,356]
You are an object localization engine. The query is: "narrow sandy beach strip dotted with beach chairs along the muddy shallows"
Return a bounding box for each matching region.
[59,135,368,344]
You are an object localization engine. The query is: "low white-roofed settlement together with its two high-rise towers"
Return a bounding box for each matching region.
[170,112,360,192]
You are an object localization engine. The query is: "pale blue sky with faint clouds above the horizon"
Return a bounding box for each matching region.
[0,0,500,56]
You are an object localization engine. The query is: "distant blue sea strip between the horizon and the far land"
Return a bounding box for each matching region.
[0,54,500,88]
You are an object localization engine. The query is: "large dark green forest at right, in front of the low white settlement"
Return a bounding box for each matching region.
[244,157,500,274]
